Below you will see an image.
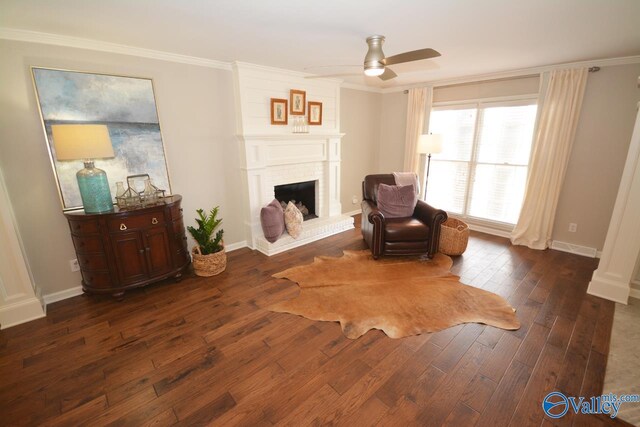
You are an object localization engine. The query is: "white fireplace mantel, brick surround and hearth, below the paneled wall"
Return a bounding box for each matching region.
[238,133,353,255]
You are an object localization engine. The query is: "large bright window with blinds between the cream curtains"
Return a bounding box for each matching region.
[426,99,537,224]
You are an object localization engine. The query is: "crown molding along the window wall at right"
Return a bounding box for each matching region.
[382,55,640,93]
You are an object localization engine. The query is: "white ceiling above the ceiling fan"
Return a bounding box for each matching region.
[0,0,640,87]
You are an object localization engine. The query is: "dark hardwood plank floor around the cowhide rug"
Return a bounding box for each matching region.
[0,221,623,427]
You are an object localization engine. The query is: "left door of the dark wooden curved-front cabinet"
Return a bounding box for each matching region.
[111,231,147,284]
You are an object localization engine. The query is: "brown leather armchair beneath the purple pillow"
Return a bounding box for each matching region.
[362,174,447,259]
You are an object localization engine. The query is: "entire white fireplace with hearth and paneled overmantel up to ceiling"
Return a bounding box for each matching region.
[233,62,353,255]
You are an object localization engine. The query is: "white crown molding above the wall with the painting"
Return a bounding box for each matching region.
[0,27,231,71]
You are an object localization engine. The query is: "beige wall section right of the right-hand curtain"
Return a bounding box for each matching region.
[552,64,640,250]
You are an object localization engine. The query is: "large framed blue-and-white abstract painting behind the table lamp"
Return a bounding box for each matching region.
[32,67,171,210]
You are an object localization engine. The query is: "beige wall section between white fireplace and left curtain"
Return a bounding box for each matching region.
[340,89,383,213]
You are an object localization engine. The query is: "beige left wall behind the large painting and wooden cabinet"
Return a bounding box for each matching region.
[0,40,244,295]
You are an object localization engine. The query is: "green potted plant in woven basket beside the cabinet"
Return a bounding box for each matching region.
[187,206,227,277]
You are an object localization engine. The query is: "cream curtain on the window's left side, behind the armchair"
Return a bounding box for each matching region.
[404,87,433,175]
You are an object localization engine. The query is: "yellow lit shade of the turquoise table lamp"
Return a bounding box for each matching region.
[51,124,114,160]
